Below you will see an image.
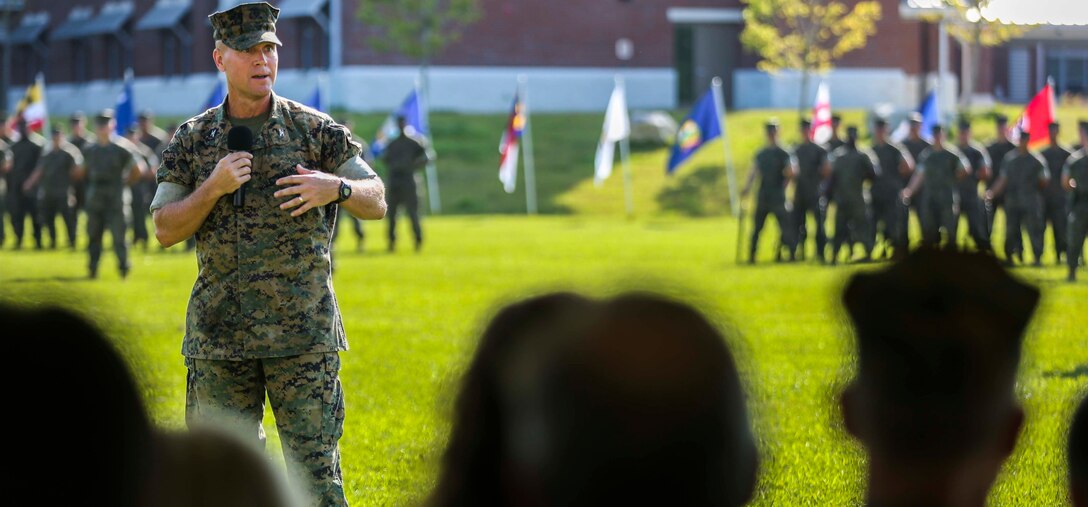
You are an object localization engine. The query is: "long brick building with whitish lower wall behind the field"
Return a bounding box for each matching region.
[0,0,1088,114]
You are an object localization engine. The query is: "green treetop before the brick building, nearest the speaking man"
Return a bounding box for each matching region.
[357,0,481,88]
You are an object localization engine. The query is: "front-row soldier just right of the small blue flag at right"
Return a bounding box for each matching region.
[903,125,969,248]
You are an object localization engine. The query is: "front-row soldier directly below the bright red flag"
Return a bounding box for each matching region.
[986,132,1050,267]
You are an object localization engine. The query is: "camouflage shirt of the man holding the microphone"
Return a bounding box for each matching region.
[158,95,361,360]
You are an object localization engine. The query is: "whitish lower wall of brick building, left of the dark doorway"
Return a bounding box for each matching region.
[11,66,677,115]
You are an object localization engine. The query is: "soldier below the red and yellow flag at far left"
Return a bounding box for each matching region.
[8,119,46,250]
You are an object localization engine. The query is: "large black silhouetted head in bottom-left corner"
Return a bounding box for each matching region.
[0,305,151,506]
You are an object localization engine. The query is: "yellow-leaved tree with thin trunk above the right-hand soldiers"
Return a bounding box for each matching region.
[741,0,880,112]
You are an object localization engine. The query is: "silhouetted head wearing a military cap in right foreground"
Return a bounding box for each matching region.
[842,249,1039,499]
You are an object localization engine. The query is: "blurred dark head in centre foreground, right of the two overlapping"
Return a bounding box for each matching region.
[539,293,757,506]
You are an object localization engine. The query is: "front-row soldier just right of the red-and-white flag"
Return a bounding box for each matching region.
[830,126,879,265]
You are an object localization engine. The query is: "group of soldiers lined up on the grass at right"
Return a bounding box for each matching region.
[741,113,1088,281]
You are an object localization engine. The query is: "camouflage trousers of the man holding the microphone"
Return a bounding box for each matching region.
[185,353,347,506]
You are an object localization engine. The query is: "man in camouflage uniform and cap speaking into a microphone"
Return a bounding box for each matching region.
[151,2,385,506]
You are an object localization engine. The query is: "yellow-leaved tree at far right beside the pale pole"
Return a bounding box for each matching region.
[942,0,1026,110]
